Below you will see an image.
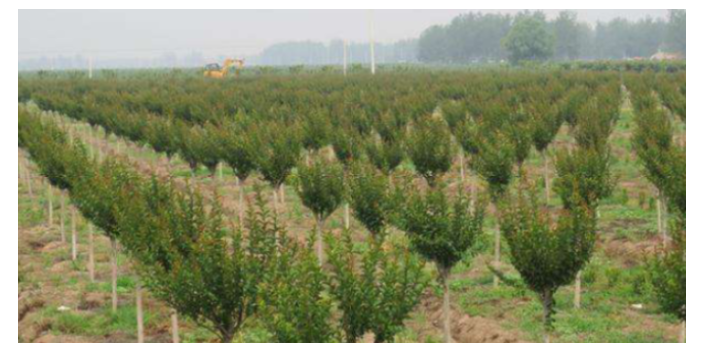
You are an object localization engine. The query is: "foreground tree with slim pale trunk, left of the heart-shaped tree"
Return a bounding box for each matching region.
[398,189,484,343]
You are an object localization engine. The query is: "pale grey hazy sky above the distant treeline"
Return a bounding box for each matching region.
[17,9,667,58]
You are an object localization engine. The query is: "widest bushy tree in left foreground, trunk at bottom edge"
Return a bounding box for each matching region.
[121,187,287,343]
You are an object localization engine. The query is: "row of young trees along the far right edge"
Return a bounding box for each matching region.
[627,76,687,343]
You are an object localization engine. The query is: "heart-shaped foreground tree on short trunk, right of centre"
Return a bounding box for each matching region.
[501,191,597,342]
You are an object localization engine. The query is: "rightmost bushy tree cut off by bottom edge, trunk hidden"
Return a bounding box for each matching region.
[326,232,428,343]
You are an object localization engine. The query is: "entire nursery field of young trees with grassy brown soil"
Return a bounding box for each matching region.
[18,68,686,343]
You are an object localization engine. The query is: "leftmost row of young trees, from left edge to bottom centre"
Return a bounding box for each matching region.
[18,107,440,342]
